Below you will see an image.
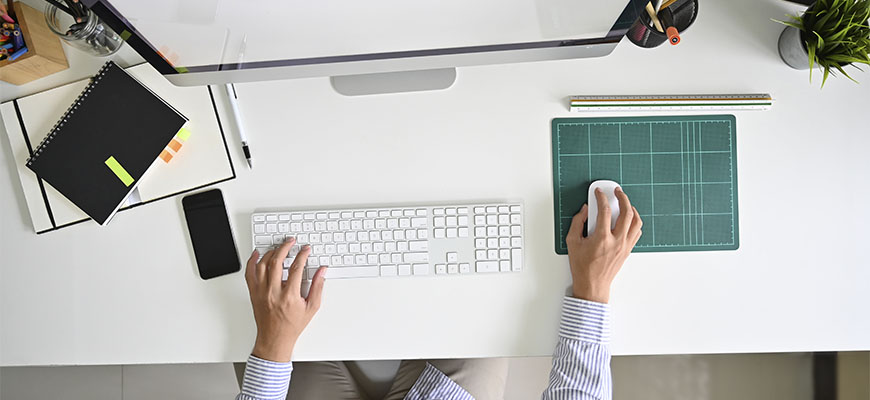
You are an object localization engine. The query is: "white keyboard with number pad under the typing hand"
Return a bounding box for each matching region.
[251,203,523,280]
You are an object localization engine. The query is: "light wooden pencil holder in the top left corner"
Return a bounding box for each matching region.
[0,2,69,85]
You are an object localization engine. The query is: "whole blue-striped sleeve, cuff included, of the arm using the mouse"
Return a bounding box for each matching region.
[542,297,613,400]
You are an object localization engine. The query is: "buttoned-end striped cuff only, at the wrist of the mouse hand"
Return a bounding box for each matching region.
[559,296,610,344]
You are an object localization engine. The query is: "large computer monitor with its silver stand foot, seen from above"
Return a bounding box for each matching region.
[82,0,646,94]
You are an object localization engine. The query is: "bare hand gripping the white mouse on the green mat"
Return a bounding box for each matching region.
[566,187,643,303]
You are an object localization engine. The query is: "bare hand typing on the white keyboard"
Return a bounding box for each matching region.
[245,238,326,362]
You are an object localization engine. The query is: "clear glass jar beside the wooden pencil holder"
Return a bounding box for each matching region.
[45,4,124,57]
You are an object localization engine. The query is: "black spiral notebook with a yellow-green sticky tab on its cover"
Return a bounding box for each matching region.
[27,61,187,225]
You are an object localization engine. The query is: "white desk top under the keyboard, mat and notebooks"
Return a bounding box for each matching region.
[0,0,870,366]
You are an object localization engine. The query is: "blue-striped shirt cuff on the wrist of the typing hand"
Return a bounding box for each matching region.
[236,354,293,400]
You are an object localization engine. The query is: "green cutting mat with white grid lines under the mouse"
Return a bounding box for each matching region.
[553,115,739,254]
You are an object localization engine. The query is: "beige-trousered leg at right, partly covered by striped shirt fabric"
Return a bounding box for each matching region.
[384,358,508,400]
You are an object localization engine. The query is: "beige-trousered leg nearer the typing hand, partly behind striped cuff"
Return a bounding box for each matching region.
[234,361,366,400]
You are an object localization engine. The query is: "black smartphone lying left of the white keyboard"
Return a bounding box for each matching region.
[181,189,241,279]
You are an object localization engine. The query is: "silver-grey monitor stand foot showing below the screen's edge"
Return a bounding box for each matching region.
[329,68,456,96]
